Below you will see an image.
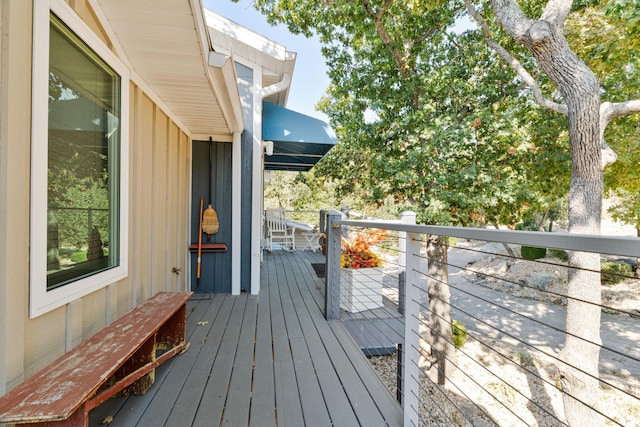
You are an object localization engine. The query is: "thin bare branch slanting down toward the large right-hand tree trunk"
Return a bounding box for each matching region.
[464,0,568,116]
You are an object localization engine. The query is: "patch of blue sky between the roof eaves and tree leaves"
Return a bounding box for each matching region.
[203,0,329,121]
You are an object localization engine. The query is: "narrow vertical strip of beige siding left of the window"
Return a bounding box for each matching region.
[0,0,31,391]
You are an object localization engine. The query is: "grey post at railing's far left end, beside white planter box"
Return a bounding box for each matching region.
[324,211,342,320]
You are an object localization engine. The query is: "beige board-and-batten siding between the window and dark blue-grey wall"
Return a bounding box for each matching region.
[127,83,191,315]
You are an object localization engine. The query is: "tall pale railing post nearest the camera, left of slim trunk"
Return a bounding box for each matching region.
[402,233,420,426]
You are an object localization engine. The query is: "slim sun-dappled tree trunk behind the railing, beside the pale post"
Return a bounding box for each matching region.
[427,236,456,385]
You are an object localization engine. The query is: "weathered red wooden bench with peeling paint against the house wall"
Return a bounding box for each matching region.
[0,292,192,427]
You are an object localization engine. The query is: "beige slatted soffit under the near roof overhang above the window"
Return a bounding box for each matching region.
[96,0,242,137]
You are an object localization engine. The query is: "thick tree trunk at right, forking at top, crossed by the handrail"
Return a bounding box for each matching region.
[493,0,604,427]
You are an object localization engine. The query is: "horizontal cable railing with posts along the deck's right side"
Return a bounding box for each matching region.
[325,212,640,426]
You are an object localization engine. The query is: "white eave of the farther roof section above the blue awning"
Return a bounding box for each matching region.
[205,9,296,106]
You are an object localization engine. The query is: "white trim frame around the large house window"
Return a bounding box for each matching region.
[29,0,130,319]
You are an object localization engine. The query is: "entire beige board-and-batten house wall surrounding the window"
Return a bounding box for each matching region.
[0,0,191,394]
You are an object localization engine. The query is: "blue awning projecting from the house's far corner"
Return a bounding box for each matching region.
[262,102,338,171]
